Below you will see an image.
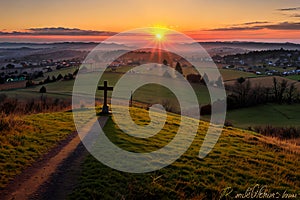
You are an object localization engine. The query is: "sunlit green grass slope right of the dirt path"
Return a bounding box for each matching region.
[69,108,300,199]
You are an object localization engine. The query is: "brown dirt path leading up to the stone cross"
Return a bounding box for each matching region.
[0,116,108,200]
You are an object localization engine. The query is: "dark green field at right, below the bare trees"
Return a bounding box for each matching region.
[226,104,300,128]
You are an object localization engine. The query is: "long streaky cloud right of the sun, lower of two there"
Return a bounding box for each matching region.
[210,22,300,31]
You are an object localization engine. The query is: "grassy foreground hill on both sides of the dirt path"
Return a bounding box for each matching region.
[0,108,300,199]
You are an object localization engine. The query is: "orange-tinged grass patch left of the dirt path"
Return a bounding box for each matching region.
[0,108,93,188]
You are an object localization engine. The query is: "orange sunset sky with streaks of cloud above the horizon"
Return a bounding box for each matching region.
[0,0,300,43]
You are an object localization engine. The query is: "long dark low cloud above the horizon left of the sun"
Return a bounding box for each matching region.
[0,27,116,36]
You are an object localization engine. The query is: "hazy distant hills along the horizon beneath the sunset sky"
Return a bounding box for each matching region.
[0,41,300,61]
